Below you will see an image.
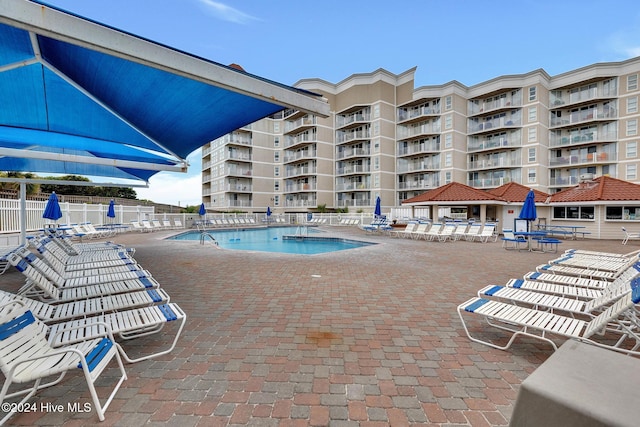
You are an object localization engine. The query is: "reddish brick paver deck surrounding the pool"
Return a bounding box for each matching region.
[0,226,640,427]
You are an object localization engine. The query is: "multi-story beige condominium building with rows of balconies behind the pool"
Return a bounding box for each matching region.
[202,58,640,212]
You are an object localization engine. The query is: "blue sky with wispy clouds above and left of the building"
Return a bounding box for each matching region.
[44,0,640,206]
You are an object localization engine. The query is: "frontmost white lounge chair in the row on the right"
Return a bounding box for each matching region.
[458,287,640,355]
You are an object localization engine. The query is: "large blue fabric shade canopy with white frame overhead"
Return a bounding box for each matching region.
[0,0,328,181]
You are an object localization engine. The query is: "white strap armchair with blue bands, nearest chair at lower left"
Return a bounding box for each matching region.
[0,303,127,424]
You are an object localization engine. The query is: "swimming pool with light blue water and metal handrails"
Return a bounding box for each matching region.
[169,227,375,255]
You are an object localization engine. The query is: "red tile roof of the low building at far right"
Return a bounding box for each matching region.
[550,176,640,203]
